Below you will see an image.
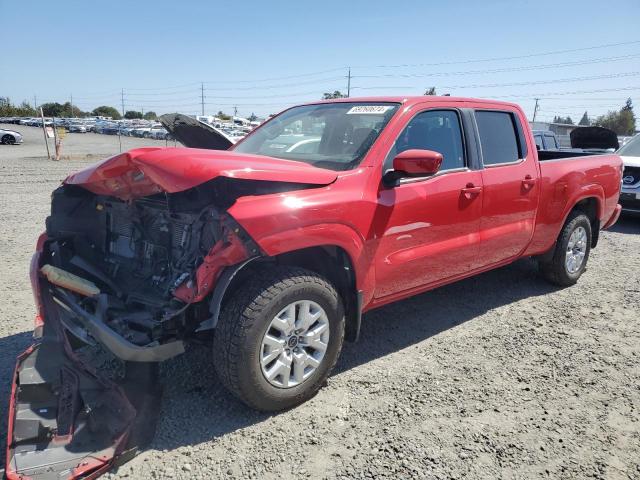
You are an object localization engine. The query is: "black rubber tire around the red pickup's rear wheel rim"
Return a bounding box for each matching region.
[539,210,592,287]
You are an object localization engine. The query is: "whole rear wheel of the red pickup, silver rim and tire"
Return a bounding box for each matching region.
[540,211,592,287]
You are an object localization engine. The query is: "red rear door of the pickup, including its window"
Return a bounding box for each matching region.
[475,110,540,266]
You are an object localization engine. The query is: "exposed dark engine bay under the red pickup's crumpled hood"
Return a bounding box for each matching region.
[43,186,222,356]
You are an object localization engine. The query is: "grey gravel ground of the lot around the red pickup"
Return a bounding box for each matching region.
[0,126,640,479]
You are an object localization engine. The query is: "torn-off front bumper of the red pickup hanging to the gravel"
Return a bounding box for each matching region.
[5,290,160,480]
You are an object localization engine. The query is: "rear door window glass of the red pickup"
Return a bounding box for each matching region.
[476,110,520,165]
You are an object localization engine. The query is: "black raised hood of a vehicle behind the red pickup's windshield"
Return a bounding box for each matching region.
[158,113,235,150]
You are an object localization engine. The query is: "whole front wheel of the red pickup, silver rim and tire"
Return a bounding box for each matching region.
[213,267,344,411]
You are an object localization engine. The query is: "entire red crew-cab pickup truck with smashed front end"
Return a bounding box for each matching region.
[7,96,622,478]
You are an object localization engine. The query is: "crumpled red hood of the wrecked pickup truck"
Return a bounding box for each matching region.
[64,147,337,200]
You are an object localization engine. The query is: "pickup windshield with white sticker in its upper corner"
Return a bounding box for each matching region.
[233,102,399,170]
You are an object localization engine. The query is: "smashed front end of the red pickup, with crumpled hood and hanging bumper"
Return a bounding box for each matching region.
[5,149,330,480]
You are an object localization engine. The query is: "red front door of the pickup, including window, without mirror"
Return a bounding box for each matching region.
[375,110,483,298]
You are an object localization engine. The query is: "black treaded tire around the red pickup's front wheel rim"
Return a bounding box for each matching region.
[213,266,345,411]
